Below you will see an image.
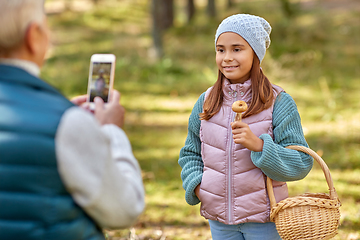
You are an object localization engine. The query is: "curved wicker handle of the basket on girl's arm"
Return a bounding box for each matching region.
[266,145,338,208]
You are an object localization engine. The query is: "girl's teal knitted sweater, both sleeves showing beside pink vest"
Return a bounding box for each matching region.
[179,92,313,205]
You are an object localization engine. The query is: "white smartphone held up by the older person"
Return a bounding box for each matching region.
[87,54,116,110]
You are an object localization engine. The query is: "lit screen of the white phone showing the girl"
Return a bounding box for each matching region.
[90,62,113,102]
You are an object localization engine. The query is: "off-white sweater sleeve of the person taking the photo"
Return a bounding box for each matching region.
[55,107,145,229]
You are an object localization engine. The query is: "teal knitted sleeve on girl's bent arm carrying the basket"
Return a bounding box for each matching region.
[251,92,313,182]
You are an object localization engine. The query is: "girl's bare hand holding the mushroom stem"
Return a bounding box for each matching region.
[231,121,264,152]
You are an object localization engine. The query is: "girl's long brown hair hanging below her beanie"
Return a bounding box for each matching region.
[199,55,274,120]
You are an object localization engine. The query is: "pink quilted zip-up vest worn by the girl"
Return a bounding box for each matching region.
[200,80,288,225]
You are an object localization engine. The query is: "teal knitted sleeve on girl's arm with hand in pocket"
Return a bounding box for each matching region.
[179,93,205,205]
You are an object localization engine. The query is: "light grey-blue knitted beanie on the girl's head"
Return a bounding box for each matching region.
[215,14,271,62]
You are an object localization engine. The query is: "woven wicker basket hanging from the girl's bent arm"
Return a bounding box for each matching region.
[267,146,341,240]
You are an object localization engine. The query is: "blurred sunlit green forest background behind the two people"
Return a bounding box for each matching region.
[42,0,360,240]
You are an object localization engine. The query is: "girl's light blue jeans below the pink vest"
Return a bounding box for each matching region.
[209,220,281,240]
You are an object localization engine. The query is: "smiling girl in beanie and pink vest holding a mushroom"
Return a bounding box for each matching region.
[179,14,313,240]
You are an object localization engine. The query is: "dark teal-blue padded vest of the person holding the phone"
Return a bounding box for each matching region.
[0,65,104,240]
